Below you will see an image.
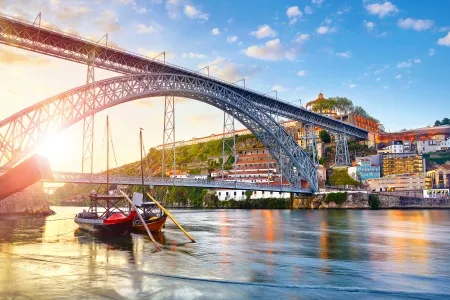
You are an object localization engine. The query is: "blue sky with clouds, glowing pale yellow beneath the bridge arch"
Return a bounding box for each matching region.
[0,0,450,171]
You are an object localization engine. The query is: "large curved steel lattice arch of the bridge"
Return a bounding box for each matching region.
[0,74,318,191]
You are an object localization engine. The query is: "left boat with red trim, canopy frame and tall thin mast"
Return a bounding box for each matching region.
[74,117,137,236]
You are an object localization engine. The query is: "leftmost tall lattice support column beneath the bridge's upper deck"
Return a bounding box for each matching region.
[81,50,95,174]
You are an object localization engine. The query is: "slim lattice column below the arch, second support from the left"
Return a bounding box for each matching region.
[161,96,177,177]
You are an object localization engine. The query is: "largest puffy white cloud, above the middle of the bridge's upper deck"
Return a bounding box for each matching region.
[244,39,296,61]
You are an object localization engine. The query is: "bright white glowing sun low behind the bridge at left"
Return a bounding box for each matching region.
[36,133,77,171]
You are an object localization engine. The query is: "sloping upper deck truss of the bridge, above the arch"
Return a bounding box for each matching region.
[0,14,368,139]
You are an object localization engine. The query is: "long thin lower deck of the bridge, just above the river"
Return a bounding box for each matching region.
[47,172,311,194]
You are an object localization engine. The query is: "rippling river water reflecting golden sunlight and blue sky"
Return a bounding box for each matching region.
[0,207,450,299]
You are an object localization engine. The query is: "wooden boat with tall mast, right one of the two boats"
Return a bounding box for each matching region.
[133,128,167,233]
